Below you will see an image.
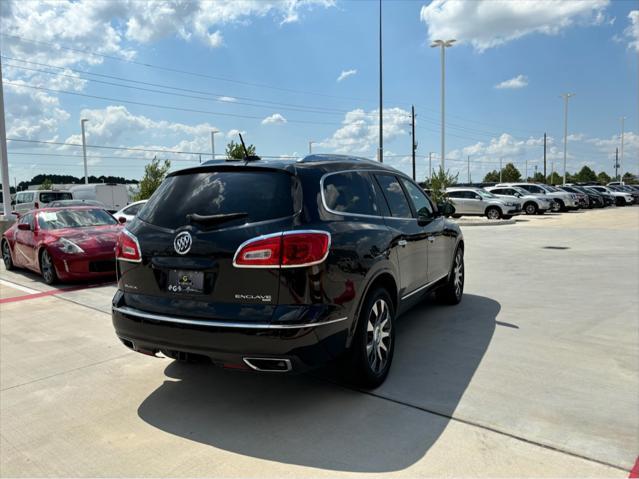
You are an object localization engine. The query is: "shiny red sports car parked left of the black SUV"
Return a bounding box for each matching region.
[2,207,122,284]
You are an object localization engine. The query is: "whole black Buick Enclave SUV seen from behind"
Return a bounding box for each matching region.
[113,155,464,387]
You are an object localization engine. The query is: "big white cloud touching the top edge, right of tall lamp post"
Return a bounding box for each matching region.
[420,0,609,52]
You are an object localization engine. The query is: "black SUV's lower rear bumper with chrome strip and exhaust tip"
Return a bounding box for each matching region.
[112,295,349,371]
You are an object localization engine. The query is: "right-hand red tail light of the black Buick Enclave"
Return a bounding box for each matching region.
[238,230,331,268]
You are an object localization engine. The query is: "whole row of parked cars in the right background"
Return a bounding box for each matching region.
[446,183,639,220]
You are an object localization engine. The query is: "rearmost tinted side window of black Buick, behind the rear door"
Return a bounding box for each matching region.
[323,171,380,216]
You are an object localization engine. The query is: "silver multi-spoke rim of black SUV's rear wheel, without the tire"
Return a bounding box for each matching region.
[366,299,392,374]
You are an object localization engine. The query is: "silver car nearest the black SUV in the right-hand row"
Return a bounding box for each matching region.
[446,187,522,220]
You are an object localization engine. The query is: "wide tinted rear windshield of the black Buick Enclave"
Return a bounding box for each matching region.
[138,171,294,229]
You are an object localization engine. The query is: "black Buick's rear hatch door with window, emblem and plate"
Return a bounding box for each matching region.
[120,165,301,321]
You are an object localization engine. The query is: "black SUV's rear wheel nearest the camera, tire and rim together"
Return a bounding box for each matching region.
[347,288,395,389]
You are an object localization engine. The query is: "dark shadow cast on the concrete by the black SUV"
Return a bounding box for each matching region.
[138,294,500,473]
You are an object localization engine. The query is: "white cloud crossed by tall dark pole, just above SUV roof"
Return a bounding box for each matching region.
[319,108,410,154]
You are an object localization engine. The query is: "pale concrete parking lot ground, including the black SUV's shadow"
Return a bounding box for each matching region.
[0,207,639,477]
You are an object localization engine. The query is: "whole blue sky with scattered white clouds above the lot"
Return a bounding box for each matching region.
[0,0,639,185]
